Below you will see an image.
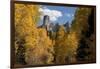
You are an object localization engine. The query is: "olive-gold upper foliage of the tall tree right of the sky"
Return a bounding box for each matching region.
[71,7,91,34]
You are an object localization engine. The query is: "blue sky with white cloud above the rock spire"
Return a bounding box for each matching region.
[39,5,76,25]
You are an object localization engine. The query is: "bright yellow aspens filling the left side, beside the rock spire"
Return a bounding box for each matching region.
[15,4,53,65]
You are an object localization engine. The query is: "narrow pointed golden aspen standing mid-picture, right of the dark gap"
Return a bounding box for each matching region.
[55,26,66,64]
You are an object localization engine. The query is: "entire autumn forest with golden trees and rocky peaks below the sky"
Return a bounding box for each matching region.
[14,3,96,66]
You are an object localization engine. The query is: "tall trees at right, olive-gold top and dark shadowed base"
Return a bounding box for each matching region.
[71,7,95,62]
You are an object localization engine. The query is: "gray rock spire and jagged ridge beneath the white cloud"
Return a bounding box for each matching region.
[39,15,70,34]
